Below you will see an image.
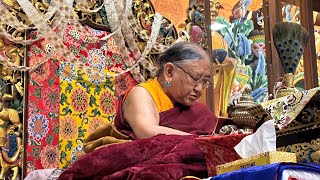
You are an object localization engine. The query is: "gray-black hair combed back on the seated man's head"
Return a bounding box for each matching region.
[157,41,210,77]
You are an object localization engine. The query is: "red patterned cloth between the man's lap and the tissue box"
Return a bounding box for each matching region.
[196,134,246,176]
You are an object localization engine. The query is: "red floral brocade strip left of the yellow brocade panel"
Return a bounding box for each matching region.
[25,36,60,172]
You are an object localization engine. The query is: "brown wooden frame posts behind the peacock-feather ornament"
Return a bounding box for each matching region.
[263,0,320,93]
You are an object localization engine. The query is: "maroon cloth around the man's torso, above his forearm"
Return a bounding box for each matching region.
[114,101,217,139]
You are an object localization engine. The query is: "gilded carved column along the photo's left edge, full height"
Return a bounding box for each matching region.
[0,0,25,170]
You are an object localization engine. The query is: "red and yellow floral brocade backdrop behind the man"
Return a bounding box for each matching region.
[27,26,136,172]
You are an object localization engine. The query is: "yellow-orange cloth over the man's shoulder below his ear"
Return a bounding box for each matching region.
[139,78,173,113]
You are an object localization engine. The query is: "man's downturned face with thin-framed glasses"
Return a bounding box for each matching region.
[169,59,212,106]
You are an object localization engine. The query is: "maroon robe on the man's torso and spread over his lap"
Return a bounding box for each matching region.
[59,103,242,180]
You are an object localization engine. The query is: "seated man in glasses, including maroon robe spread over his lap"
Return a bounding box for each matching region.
[59,42,244,180]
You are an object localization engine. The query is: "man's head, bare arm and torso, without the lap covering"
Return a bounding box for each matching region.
[115,42,216,139]
